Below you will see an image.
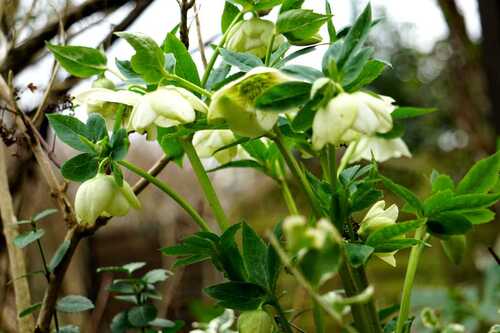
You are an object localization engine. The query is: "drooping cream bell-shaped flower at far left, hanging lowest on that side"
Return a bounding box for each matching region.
[75,174,141,225]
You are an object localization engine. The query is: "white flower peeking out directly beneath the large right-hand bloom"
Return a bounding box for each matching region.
[341,136,411,165]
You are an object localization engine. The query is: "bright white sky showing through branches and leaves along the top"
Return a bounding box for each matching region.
[16,0,481,108]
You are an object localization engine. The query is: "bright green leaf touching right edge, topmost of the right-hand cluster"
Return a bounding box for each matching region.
[457,151,500,194]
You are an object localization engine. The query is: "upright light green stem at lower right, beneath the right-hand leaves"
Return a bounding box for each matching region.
[396,226,426,333]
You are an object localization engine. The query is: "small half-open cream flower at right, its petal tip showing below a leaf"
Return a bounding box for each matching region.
[358,200,399,267]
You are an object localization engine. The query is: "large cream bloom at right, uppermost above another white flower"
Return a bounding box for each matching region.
[312,92,395,150]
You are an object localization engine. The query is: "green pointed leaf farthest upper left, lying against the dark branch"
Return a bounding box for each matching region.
[46,42,107,78]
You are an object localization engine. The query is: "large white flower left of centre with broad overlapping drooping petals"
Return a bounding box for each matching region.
[128,86,207,138]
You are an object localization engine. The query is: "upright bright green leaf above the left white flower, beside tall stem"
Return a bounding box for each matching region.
[162,32,201,86]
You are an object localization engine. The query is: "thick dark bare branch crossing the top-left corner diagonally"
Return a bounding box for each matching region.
[0,0,133,74]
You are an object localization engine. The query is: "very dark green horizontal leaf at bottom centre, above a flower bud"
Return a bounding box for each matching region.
[204,282,266,311]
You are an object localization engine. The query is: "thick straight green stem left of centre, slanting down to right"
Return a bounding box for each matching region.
[181,138,229,231]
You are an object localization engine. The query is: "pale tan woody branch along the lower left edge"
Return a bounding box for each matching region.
[0,141,35,333]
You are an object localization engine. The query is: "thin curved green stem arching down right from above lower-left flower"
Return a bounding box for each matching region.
[118,160,211,231]
